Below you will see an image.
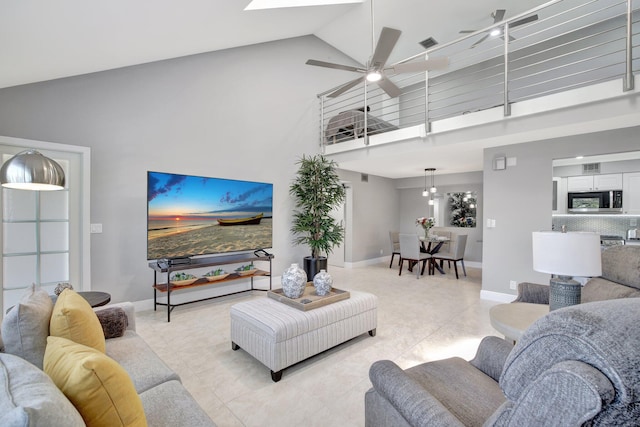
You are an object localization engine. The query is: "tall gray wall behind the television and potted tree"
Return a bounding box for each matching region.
[0,36,358,301]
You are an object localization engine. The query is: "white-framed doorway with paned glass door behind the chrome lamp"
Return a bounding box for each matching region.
[0,137,91,318]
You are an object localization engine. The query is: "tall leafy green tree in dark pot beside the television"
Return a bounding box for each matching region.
[289,154,345,281]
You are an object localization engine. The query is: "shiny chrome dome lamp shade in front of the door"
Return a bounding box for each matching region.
[0,149,65,191]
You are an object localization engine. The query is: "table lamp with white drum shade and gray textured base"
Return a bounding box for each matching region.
[533,231,602,311]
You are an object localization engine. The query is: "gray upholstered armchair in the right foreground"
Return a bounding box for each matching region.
[365,298,640,427]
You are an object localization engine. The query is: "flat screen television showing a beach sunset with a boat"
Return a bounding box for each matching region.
[147,172,273,260]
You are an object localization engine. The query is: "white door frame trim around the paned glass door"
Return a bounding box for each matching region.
[0,135,91,319]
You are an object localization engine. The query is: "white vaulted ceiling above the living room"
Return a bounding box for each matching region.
[0,0,564,176]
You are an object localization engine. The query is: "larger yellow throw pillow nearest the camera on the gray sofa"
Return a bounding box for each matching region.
[44,337,147,427]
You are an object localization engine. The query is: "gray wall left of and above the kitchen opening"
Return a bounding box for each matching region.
[482,123,639,295]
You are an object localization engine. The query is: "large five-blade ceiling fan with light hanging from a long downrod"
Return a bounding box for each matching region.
[306,0,449,98]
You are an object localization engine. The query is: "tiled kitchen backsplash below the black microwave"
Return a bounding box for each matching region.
[552,215,640,238]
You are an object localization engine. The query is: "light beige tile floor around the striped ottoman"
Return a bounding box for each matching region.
[136,263,499,427]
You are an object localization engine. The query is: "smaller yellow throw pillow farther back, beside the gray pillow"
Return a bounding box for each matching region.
[49,289,105,353]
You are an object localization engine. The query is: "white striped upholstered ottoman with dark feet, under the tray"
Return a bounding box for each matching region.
[231,291,378,381]
